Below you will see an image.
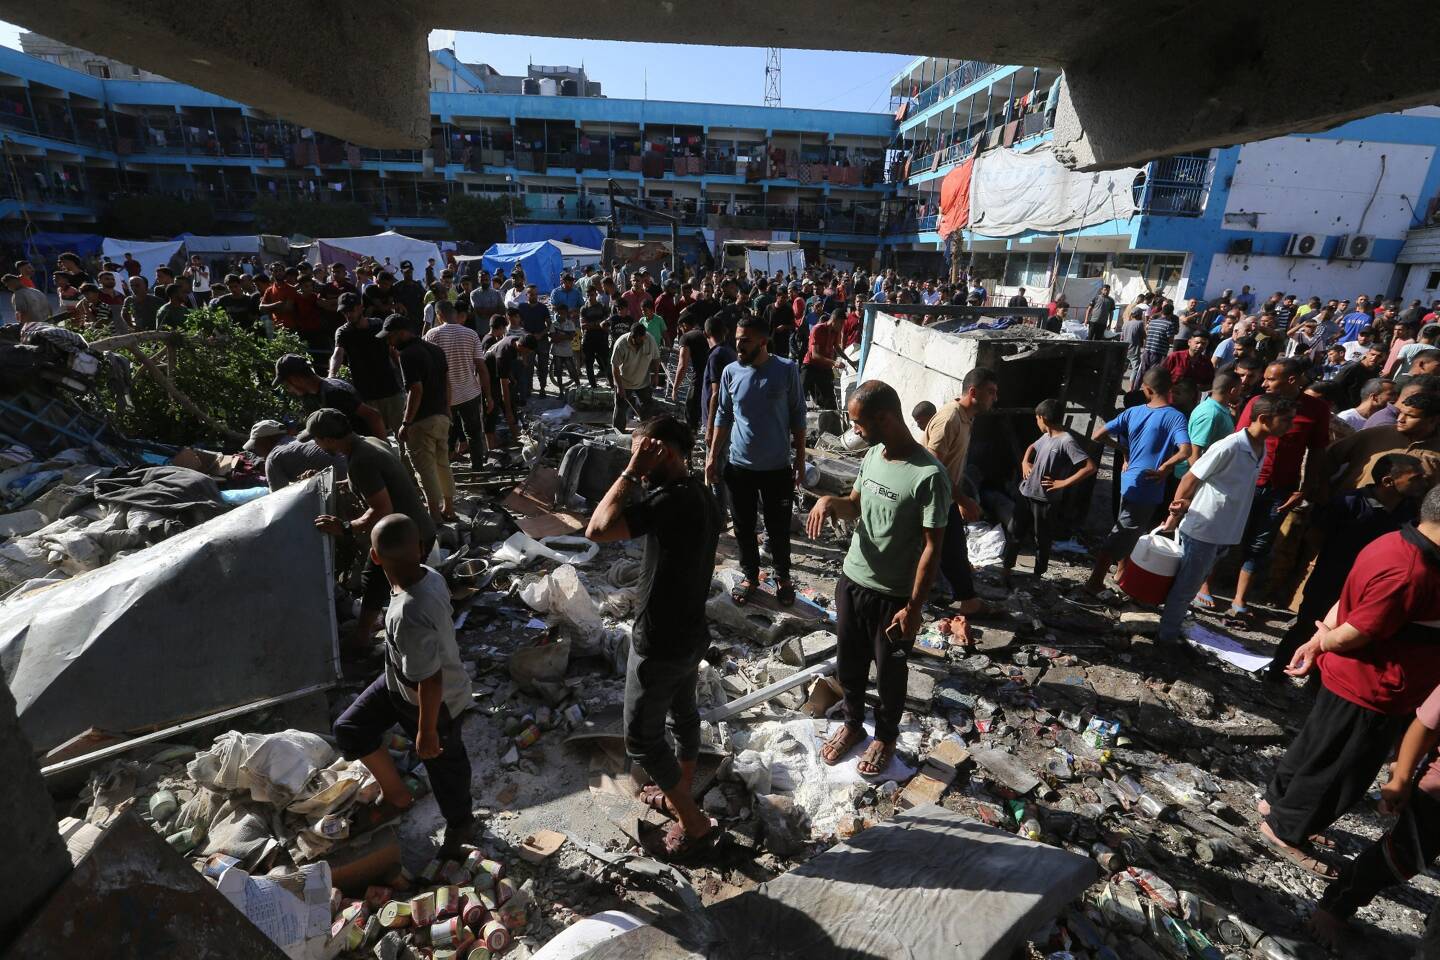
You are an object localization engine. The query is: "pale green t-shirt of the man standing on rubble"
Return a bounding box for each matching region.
[844,445,952,597]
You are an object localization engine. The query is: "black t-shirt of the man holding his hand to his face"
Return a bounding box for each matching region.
[624,476,721,656]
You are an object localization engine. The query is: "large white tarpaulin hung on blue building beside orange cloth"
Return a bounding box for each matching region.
[969,144,1140,236]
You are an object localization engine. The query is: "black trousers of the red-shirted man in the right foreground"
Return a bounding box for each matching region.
[1266,684,1411,846]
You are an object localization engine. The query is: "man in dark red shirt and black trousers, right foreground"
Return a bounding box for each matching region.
[1260,486,1440,877]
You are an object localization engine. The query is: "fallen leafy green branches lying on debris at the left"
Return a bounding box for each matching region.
[120,307,305,446]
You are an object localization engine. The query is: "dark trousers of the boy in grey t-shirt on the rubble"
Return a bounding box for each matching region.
[334,674,475,828]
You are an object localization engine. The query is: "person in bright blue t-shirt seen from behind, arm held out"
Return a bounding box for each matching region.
[1080,367,1189,597]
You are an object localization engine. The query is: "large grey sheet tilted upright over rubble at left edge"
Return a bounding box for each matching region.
[0,472,340,753]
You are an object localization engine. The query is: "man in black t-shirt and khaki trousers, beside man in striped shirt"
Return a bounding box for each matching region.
[377,314,455,522]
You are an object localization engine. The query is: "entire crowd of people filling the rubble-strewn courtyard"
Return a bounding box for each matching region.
[14,240,1440,940]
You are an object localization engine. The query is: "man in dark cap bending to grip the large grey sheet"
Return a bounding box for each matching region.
[305,407,435,652]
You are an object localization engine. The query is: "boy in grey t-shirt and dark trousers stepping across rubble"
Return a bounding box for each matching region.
[334,514,475,852]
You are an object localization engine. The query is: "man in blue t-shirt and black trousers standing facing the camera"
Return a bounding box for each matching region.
[706,317,805,606]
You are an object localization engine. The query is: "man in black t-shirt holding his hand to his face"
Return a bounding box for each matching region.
[585,415,720,858]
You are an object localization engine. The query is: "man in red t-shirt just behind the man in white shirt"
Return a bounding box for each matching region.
[1230,357,1330,616]
